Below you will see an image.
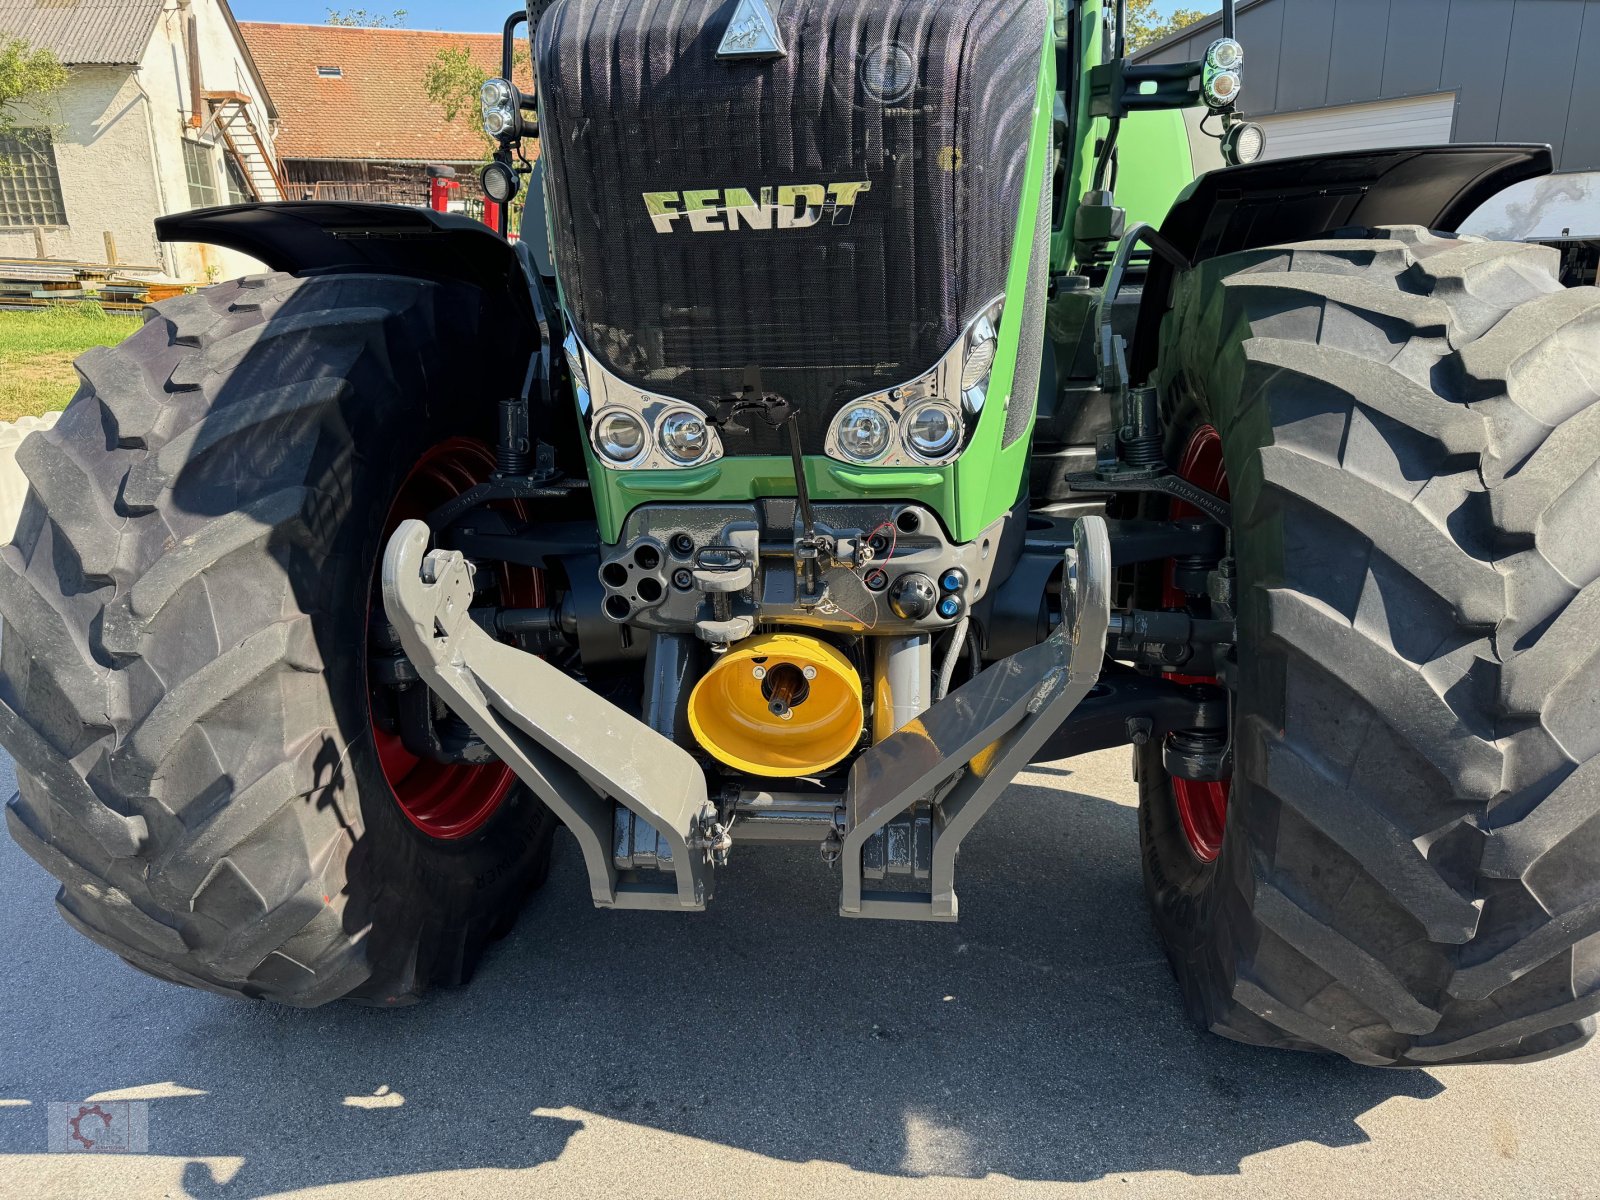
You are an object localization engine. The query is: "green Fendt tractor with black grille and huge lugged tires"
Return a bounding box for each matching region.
[0,0,1600,1066]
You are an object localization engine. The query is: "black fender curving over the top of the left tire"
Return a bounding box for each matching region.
[155,200,539,336]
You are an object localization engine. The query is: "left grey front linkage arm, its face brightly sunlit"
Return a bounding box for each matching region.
[382,520,723,910]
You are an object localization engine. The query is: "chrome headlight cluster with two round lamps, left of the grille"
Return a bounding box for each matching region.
[562,333,722,470]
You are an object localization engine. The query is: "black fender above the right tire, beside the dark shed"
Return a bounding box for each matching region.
[1130,144,1555,381]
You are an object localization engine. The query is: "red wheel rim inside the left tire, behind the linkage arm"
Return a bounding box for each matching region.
[368,437,544,842]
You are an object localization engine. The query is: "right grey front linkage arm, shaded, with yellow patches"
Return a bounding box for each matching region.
[840,517,1110,922]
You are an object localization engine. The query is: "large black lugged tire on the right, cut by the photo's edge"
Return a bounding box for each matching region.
[1139,229,1600,1066]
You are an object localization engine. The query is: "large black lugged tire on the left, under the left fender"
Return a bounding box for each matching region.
[0,275,554,1006]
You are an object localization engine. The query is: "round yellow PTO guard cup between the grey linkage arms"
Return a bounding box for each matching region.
[690,634,866,778]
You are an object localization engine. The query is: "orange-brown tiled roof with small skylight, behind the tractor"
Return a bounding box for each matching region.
[236,22,501,163]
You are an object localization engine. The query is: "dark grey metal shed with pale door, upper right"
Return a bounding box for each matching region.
[1138,0,1600,249]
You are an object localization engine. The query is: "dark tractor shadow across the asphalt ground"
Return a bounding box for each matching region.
[0,763,1443,1197]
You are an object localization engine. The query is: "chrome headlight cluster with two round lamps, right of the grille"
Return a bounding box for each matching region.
[824,296,1005,467]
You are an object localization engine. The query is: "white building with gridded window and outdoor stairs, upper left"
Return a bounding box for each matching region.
[0,0,283,283]
